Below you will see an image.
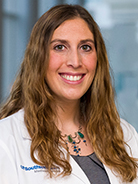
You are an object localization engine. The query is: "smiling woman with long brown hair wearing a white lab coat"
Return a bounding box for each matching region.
[0,5,138,184]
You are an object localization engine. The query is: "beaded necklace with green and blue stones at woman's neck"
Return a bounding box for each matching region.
[61,125,87,156]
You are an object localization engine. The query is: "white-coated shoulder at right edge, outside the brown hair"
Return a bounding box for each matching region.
[121,119,138,158]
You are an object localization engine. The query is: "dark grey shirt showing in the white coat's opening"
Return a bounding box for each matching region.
[72,153,110,184]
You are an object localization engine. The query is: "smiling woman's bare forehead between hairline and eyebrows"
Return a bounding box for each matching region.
[52,18,93,39]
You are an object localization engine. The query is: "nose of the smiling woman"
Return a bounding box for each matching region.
[67,50,82,68]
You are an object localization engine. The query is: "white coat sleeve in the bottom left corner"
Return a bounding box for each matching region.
[0,140,19,184]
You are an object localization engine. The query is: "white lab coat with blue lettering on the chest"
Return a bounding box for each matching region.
[0,110,138,184]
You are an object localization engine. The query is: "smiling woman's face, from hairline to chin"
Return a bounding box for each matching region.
[46,18,97,101]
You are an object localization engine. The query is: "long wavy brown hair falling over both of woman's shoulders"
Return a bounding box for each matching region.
[0,5,138,182]
